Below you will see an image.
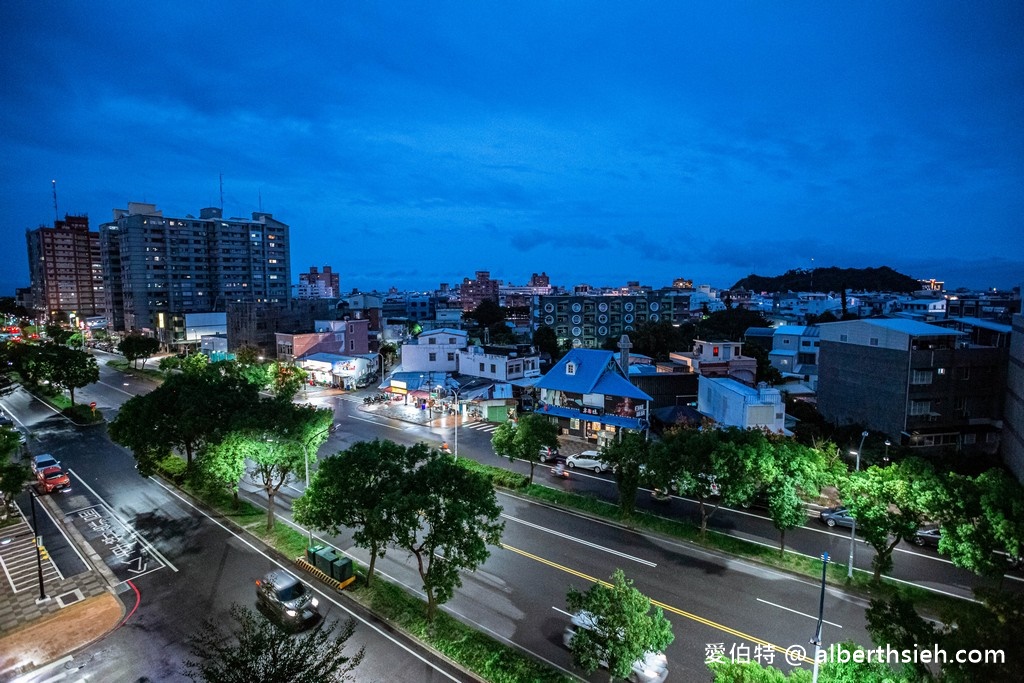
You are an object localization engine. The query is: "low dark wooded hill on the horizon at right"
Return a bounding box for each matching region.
[732,265,921,292]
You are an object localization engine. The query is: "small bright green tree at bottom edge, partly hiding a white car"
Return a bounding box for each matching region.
[565,569,675,680]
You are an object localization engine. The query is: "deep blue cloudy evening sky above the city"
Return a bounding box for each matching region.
[0,0,1024,292]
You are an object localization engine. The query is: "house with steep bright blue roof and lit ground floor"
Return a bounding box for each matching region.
[536,348,651,447]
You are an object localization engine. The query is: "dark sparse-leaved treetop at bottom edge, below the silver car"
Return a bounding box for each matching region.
[181,604,365,683]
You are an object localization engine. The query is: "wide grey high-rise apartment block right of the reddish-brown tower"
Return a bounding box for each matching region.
[99,202,291,347]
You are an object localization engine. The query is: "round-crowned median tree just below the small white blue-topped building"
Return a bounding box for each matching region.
[651,427,766,542]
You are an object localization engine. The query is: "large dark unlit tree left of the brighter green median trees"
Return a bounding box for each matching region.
[110,368,259,476]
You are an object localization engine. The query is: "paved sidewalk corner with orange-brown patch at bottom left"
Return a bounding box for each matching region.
[0,497,125,681]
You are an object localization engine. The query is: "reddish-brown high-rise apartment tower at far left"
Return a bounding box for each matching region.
[25,215,105,319]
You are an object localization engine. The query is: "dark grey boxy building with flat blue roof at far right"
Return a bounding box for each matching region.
[817,318,1010,454]
